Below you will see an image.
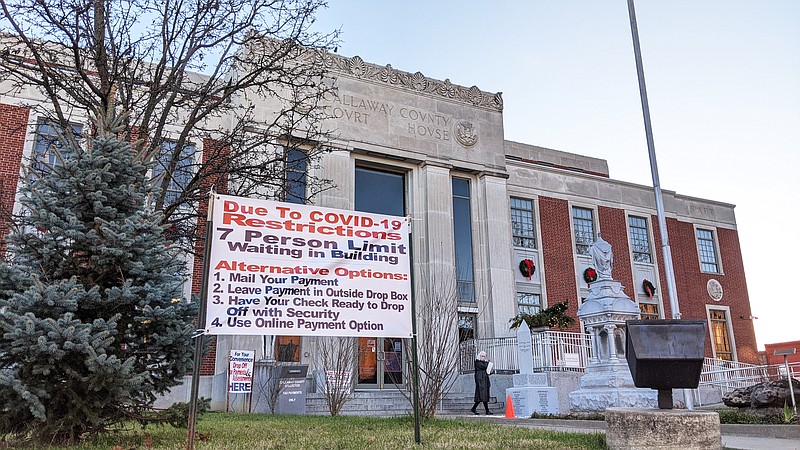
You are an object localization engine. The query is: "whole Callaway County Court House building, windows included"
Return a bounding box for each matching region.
[0,47,758,402]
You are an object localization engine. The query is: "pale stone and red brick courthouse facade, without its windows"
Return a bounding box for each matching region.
[0,49,758,412]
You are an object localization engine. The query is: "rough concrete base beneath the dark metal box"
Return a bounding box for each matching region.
[605,408,722,450]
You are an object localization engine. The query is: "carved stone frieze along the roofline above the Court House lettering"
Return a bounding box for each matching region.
[321,53,503,111]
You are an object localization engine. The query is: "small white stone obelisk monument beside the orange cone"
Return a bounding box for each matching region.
[506,320,559,418]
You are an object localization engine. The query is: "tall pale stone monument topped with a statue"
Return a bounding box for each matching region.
[569,237,658,412]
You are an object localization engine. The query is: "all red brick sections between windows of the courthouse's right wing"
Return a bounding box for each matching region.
[539,201,758,364]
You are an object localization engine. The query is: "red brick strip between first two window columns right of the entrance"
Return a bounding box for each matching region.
[539,197,580,331]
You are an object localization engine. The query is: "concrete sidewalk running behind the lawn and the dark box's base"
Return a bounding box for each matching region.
[456,414,800,450]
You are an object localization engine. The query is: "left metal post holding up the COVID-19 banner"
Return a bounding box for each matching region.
[186,190,214,450]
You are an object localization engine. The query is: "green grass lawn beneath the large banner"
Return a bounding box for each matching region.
[73,413,605,450]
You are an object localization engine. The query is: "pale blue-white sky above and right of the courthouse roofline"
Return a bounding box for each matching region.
[315,0,800,348]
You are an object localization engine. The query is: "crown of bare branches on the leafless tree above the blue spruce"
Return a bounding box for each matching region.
[0,0,338,250]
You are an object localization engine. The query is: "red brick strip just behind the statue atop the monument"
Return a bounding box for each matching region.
[597,206,636,292]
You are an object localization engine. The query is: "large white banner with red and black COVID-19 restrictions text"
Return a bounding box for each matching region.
[206,195,411,338]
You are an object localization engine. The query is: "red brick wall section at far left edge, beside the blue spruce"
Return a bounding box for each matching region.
[0,104,30,254]
